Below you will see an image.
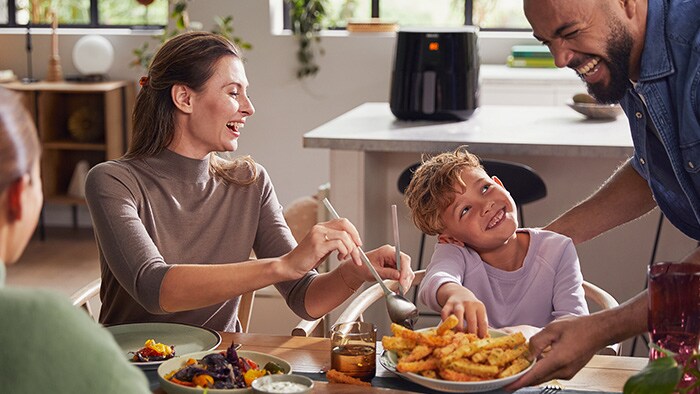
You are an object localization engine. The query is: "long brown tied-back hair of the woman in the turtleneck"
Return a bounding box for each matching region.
[124,32,257,185]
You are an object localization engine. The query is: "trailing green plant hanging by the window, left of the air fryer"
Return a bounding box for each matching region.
[286,0,326,79]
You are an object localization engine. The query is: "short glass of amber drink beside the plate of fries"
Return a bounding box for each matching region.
[331,322,377,381]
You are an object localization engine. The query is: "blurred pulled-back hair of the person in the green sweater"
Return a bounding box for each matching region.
[0,87,41,192]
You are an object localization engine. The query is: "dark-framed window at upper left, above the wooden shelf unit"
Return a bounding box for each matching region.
[0,0,168,28]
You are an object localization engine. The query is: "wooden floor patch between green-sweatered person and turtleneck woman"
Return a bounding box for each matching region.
[6,228,100,295]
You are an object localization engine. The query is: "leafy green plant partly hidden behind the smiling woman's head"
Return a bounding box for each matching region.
[130,0,253,70]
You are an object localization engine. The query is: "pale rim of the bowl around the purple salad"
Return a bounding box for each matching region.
[158,350,292,394]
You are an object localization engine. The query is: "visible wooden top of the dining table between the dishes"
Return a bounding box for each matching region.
[149,332,648,394]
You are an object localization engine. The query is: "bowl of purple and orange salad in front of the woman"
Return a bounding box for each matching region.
[158,344,292,394]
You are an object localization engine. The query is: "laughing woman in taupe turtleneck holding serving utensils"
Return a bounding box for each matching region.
[86,32,413,331]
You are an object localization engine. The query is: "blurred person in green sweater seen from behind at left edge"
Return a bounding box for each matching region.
[0,88,151,394]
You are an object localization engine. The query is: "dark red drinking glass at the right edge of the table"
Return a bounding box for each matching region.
[648,262,700,364]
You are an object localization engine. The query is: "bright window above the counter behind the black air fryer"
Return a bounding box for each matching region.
[292,0,530,30]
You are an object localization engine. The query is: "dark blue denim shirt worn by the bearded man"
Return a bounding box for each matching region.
[620,0,700,240]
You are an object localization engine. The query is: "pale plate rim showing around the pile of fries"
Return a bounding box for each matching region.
[379,329,535,393]
